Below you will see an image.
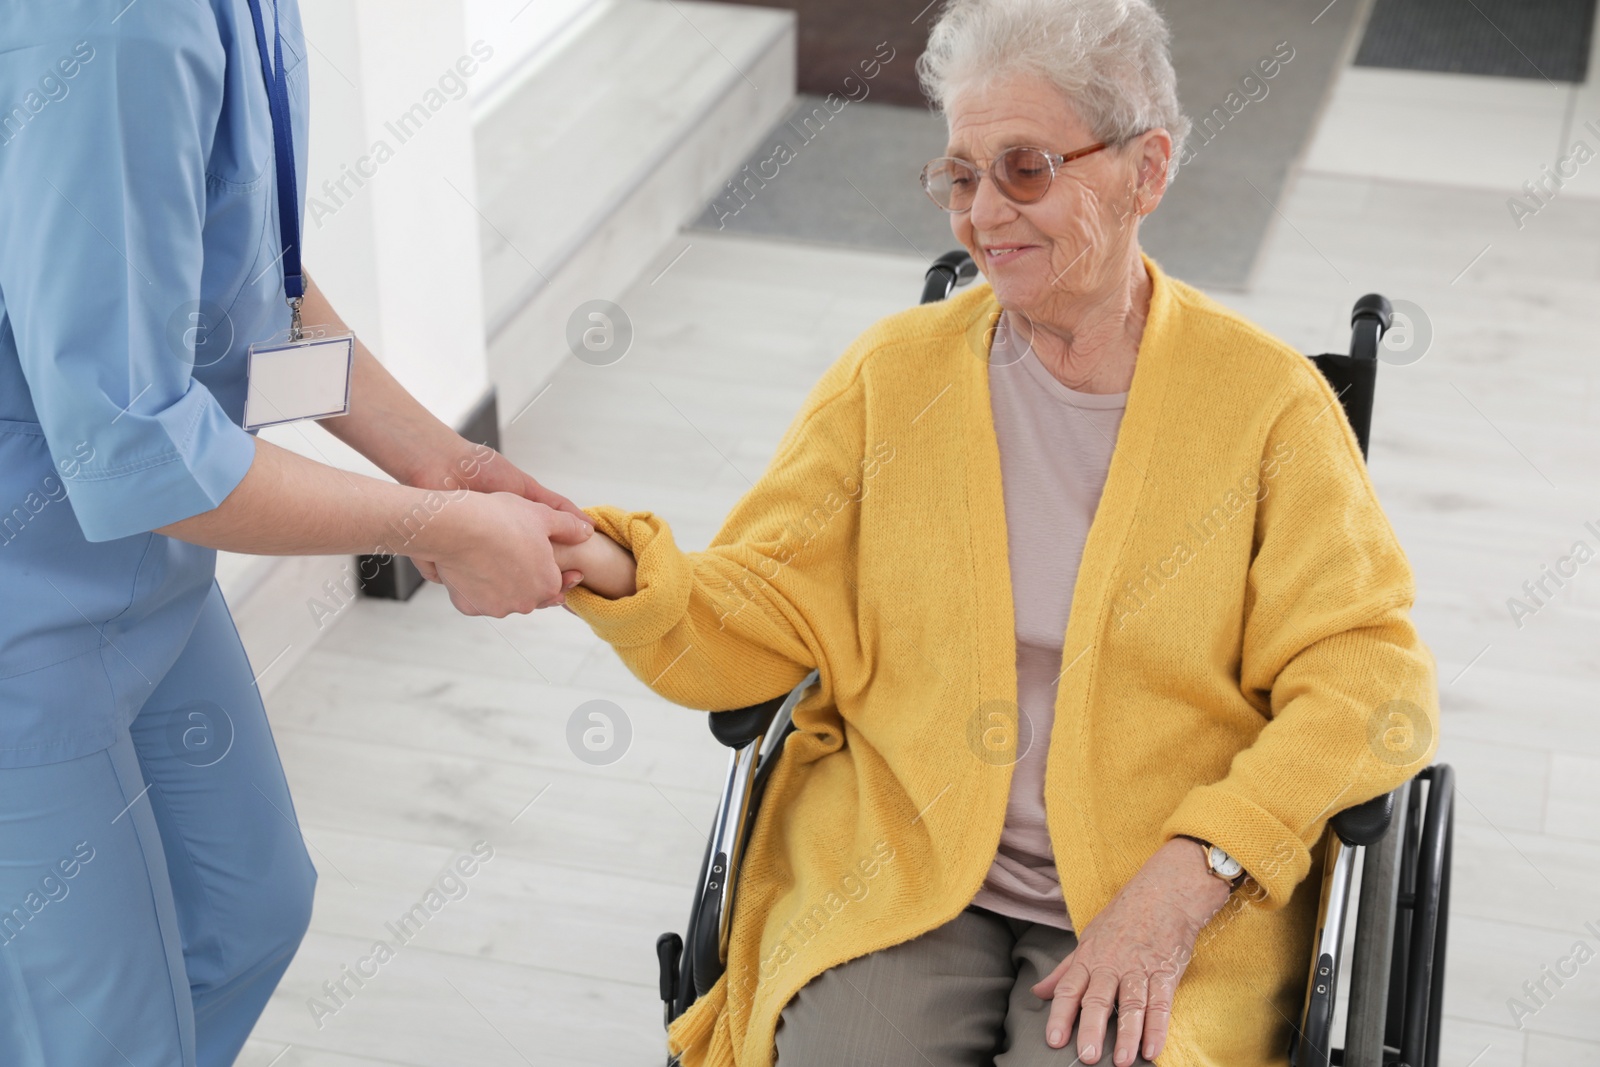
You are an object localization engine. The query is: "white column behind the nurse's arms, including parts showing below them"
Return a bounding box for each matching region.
[218,0,498,693]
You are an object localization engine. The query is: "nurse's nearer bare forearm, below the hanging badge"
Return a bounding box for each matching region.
[155,438,476,558]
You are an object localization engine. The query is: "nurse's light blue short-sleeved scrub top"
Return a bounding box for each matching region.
[0,0,307,766]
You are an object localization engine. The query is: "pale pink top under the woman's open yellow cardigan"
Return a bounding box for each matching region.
[973,314,1128,929]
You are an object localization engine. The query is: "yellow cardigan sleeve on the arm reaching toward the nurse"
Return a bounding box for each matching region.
[566,338,882,710]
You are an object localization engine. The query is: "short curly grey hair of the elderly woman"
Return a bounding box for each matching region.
[917,0,1190,176]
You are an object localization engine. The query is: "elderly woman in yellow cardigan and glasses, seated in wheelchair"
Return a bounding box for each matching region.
[562,0,1437,1067]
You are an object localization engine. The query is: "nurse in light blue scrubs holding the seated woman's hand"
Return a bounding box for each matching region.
[0,0,589,1067]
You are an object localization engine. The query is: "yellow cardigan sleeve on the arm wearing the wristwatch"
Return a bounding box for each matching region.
[1162,365,1438,909]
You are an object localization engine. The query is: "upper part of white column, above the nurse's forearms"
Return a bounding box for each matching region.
[302,0,501,441]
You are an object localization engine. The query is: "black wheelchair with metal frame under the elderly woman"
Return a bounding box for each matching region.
[656,250,1456,1067]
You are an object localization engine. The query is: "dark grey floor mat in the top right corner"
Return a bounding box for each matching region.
[1355,0,1595,82]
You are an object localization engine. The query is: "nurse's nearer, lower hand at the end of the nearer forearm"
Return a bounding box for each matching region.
[408,493,594,619]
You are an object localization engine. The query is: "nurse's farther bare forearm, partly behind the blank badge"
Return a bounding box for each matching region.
[301,275,470,485]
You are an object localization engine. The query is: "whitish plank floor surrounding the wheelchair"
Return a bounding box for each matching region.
[243,56,1600,1067]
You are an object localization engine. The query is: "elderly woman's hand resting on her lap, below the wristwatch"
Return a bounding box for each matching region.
[1034,838,1229,1067]
